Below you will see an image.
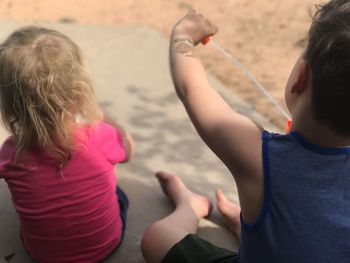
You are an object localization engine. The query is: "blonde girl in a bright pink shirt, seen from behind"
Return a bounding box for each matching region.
[0,26,133,262]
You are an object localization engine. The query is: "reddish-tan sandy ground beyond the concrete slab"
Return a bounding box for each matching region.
[0,0,319,127]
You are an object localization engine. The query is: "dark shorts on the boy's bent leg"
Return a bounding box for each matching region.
[162,234,238,263]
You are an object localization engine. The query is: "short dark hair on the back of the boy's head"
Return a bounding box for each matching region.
[304,0,350,135]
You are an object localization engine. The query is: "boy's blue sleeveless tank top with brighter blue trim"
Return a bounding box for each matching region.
[239,131,350,263]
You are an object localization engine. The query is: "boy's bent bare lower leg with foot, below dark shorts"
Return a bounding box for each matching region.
[141,172,212,263]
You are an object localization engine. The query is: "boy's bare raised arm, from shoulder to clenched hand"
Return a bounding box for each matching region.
[170,10,262,184]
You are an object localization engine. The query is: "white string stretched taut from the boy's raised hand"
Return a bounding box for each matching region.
[210,39,291,120]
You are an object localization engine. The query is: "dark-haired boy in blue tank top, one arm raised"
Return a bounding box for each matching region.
[142,0,350,263]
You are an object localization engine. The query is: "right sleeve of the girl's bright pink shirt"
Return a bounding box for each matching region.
[93,122,126,164]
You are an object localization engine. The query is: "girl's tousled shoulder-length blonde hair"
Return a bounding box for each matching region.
[0,26,100,167]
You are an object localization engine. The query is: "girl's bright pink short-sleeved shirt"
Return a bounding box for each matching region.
[0,123,126,263]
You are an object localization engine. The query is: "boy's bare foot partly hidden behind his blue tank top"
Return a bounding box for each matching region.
[215,189,241,240]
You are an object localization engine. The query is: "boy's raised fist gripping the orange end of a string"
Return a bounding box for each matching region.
[172,10,219,45]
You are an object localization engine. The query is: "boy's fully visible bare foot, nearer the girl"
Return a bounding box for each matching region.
[156,172,213,218]
